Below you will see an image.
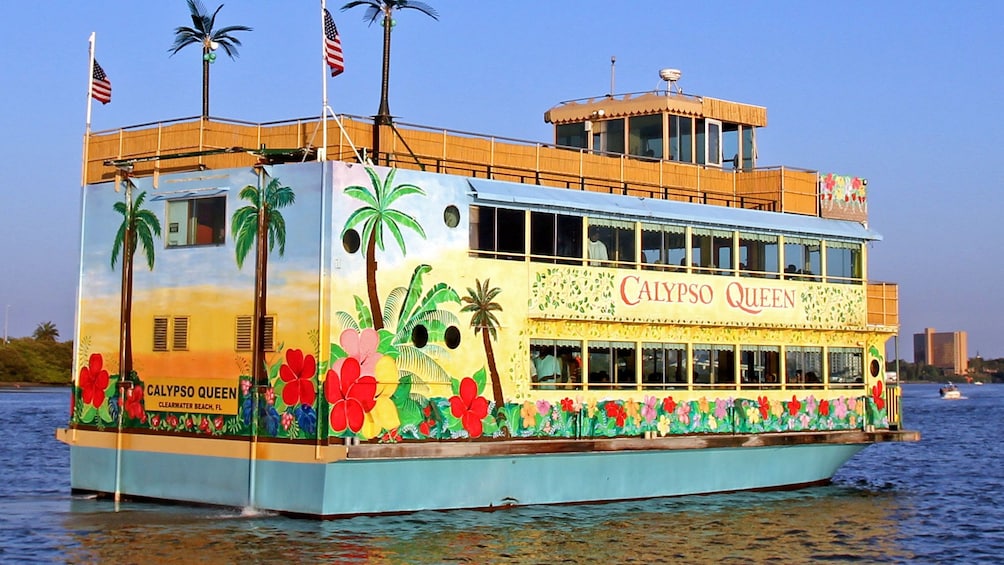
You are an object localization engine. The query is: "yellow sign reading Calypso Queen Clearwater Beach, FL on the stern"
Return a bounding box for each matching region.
[144,378,240,415]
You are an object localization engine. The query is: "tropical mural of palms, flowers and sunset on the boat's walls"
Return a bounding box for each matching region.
[71,163,888,442]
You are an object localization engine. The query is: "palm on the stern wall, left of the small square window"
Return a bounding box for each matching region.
[111,185,161,378]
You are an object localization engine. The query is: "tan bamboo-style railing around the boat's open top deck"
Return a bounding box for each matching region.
[83,115,819,216]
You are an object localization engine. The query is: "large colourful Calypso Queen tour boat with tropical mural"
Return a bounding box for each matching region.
[56,58,920,519]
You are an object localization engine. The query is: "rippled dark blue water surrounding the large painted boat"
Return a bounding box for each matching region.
[0,384,1004,563]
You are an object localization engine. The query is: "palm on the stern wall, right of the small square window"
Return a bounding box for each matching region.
[231,172,296,384]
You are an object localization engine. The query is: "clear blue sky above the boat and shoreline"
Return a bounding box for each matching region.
[0,0,1004,359]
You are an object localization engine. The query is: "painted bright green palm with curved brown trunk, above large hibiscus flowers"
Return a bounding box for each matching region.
[341,167,426,330]
